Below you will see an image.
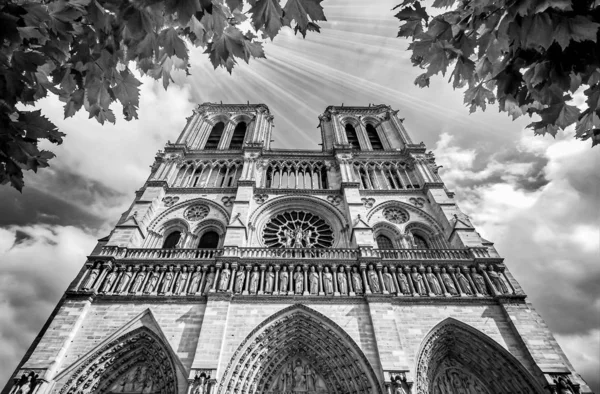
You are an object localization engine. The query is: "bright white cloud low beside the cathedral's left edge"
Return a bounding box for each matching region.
[0,225,97,382]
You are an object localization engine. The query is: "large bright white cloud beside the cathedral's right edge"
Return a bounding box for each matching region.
[435,131,600,387]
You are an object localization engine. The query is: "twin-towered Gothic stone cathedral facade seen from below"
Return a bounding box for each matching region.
[2,103,591,394]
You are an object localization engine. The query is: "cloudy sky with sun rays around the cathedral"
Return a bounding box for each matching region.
[0,0,600,392]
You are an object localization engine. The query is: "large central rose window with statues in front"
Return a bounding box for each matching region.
[263,211,334,248]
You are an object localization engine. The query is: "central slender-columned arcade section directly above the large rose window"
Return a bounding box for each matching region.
[264,160,329,190]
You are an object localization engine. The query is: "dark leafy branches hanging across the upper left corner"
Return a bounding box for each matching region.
[0,0,325,190]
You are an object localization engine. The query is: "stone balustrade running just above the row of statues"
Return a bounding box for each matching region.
[96,246,492,261]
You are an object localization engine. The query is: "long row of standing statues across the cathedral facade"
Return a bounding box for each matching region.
[80,263,512,296]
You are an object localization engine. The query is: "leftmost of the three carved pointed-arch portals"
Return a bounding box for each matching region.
[60,327,178,394]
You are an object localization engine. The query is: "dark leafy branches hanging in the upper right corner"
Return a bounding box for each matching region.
[395,0,600,146]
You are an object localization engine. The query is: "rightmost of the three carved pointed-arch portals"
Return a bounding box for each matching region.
[414,318,544,394]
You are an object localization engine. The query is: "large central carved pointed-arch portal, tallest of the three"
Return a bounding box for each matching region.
[217,305,382,394]
